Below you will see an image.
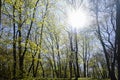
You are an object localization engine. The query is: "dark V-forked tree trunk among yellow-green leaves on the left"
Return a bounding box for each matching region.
[18,0,39,78]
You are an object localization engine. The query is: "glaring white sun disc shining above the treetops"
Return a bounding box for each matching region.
[67,9,89,29]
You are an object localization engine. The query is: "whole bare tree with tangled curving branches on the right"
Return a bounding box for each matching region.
[90,1,117,80]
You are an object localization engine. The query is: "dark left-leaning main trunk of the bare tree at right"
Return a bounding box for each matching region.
[95,1,117,80]
